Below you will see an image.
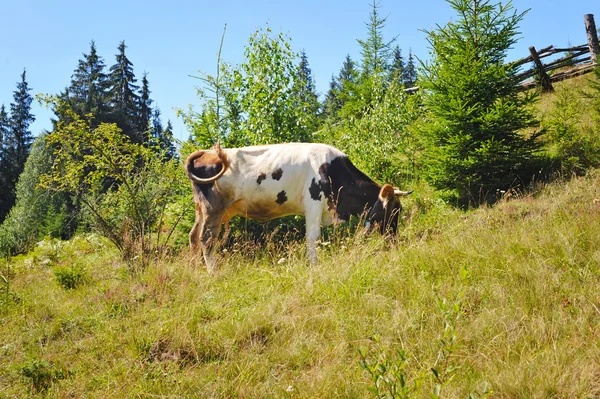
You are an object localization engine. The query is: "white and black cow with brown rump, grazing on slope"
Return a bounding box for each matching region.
[184,143,412,272]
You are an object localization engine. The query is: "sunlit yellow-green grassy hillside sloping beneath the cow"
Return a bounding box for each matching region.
[0,167,600,398]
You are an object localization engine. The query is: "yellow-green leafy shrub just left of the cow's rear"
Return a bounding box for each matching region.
[41,97,189,266]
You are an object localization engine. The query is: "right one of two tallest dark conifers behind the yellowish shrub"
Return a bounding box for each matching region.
[108,41,143,143]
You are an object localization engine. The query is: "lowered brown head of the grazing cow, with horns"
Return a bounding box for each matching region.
[367,184,412,234]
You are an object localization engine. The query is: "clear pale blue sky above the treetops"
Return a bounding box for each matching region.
[0,0,600,139]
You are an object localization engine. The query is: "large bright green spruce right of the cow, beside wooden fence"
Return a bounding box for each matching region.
[422,0,537,204]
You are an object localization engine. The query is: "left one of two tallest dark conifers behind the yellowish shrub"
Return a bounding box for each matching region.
[65,40,108,127]
